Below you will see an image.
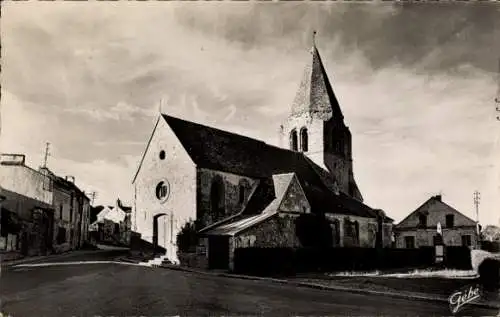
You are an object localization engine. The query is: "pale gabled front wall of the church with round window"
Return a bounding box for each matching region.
[132,117,197,262]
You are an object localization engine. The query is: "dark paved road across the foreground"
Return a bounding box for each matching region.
[0,254,498,317]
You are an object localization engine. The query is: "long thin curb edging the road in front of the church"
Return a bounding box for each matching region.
[138,264,500,309]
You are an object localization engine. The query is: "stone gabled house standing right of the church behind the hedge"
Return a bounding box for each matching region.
[394,195,478,248]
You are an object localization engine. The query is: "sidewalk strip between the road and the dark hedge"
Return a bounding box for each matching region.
[118,258,500,309]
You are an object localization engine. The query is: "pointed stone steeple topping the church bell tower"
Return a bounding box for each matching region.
[292,31,344,121]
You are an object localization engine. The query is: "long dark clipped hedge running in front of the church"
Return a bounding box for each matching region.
[234,247,471,275]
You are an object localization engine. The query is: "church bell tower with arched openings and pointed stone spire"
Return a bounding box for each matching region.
[280,32,363,201]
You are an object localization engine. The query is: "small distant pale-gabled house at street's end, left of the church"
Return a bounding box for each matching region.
[90,199,132,245]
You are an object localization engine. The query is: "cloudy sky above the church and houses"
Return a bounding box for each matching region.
[0,1,500,224]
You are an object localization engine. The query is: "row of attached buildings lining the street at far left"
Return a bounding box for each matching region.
[0,154,90,255]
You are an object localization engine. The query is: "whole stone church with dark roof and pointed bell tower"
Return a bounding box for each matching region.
[132,39,393,268]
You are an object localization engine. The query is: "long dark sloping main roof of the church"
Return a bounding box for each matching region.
[163,115,376,218]
